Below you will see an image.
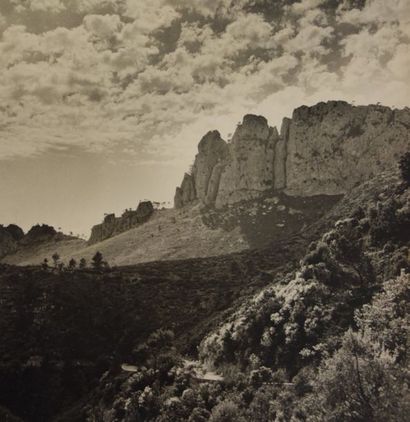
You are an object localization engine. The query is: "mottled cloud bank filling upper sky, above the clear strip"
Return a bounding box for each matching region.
[0,0,410,162]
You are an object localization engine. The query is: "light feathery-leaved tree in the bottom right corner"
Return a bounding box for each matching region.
[305,274,410,422]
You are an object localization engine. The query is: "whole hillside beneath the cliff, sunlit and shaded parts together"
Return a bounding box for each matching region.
[2,192,340,266]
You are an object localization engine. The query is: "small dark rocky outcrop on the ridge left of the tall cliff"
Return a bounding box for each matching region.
[88,201,154,245]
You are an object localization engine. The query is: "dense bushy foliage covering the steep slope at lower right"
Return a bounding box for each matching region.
[86,172,410,422]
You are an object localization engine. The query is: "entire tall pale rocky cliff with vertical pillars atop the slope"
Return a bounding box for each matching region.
[175,101,410,208]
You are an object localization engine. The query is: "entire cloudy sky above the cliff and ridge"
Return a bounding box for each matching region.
[0,0,410,235]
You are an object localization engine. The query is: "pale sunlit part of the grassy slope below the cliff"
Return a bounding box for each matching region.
[3,207,248,265]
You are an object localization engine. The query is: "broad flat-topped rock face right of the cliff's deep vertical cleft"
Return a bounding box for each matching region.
[285,101,410,196]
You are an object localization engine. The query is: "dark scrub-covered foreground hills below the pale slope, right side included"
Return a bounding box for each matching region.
[0,169,410,422]
